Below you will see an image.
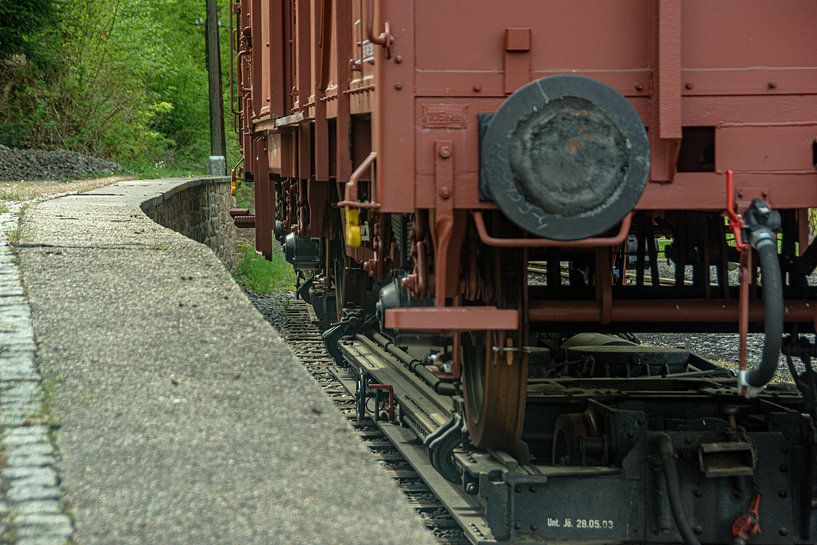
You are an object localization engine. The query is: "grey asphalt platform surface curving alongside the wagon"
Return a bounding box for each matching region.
[15,181,432,545]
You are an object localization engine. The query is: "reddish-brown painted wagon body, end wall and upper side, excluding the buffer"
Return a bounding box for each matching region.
[238,0,817,217]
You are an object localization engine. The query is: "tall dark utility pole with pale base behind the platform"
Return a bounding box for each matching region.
[206,0,227,175]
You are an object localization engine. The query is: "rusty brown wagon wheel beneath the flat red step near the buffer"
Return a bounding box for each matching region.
[463,332,528,453]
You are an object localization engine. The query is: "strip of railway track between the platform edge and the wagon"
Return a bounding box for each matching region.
[266,300,470,545]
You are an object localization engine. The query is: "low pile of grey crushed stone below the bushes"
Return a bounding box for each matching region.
[0,146,124,181]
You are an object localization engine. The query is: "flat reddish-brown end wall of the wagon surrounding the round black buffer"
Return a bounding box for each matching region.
[378,0,817,211]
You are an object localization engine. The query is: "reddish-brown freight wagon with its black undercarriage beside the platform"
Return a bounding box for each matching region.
[232,0,817,544]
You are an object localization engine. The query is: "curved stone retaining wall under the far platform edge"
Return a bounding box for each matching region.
[142,178,238,270]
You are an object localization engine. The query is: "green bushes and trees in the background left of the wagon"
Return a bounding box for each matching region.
[0,0,235,174]
